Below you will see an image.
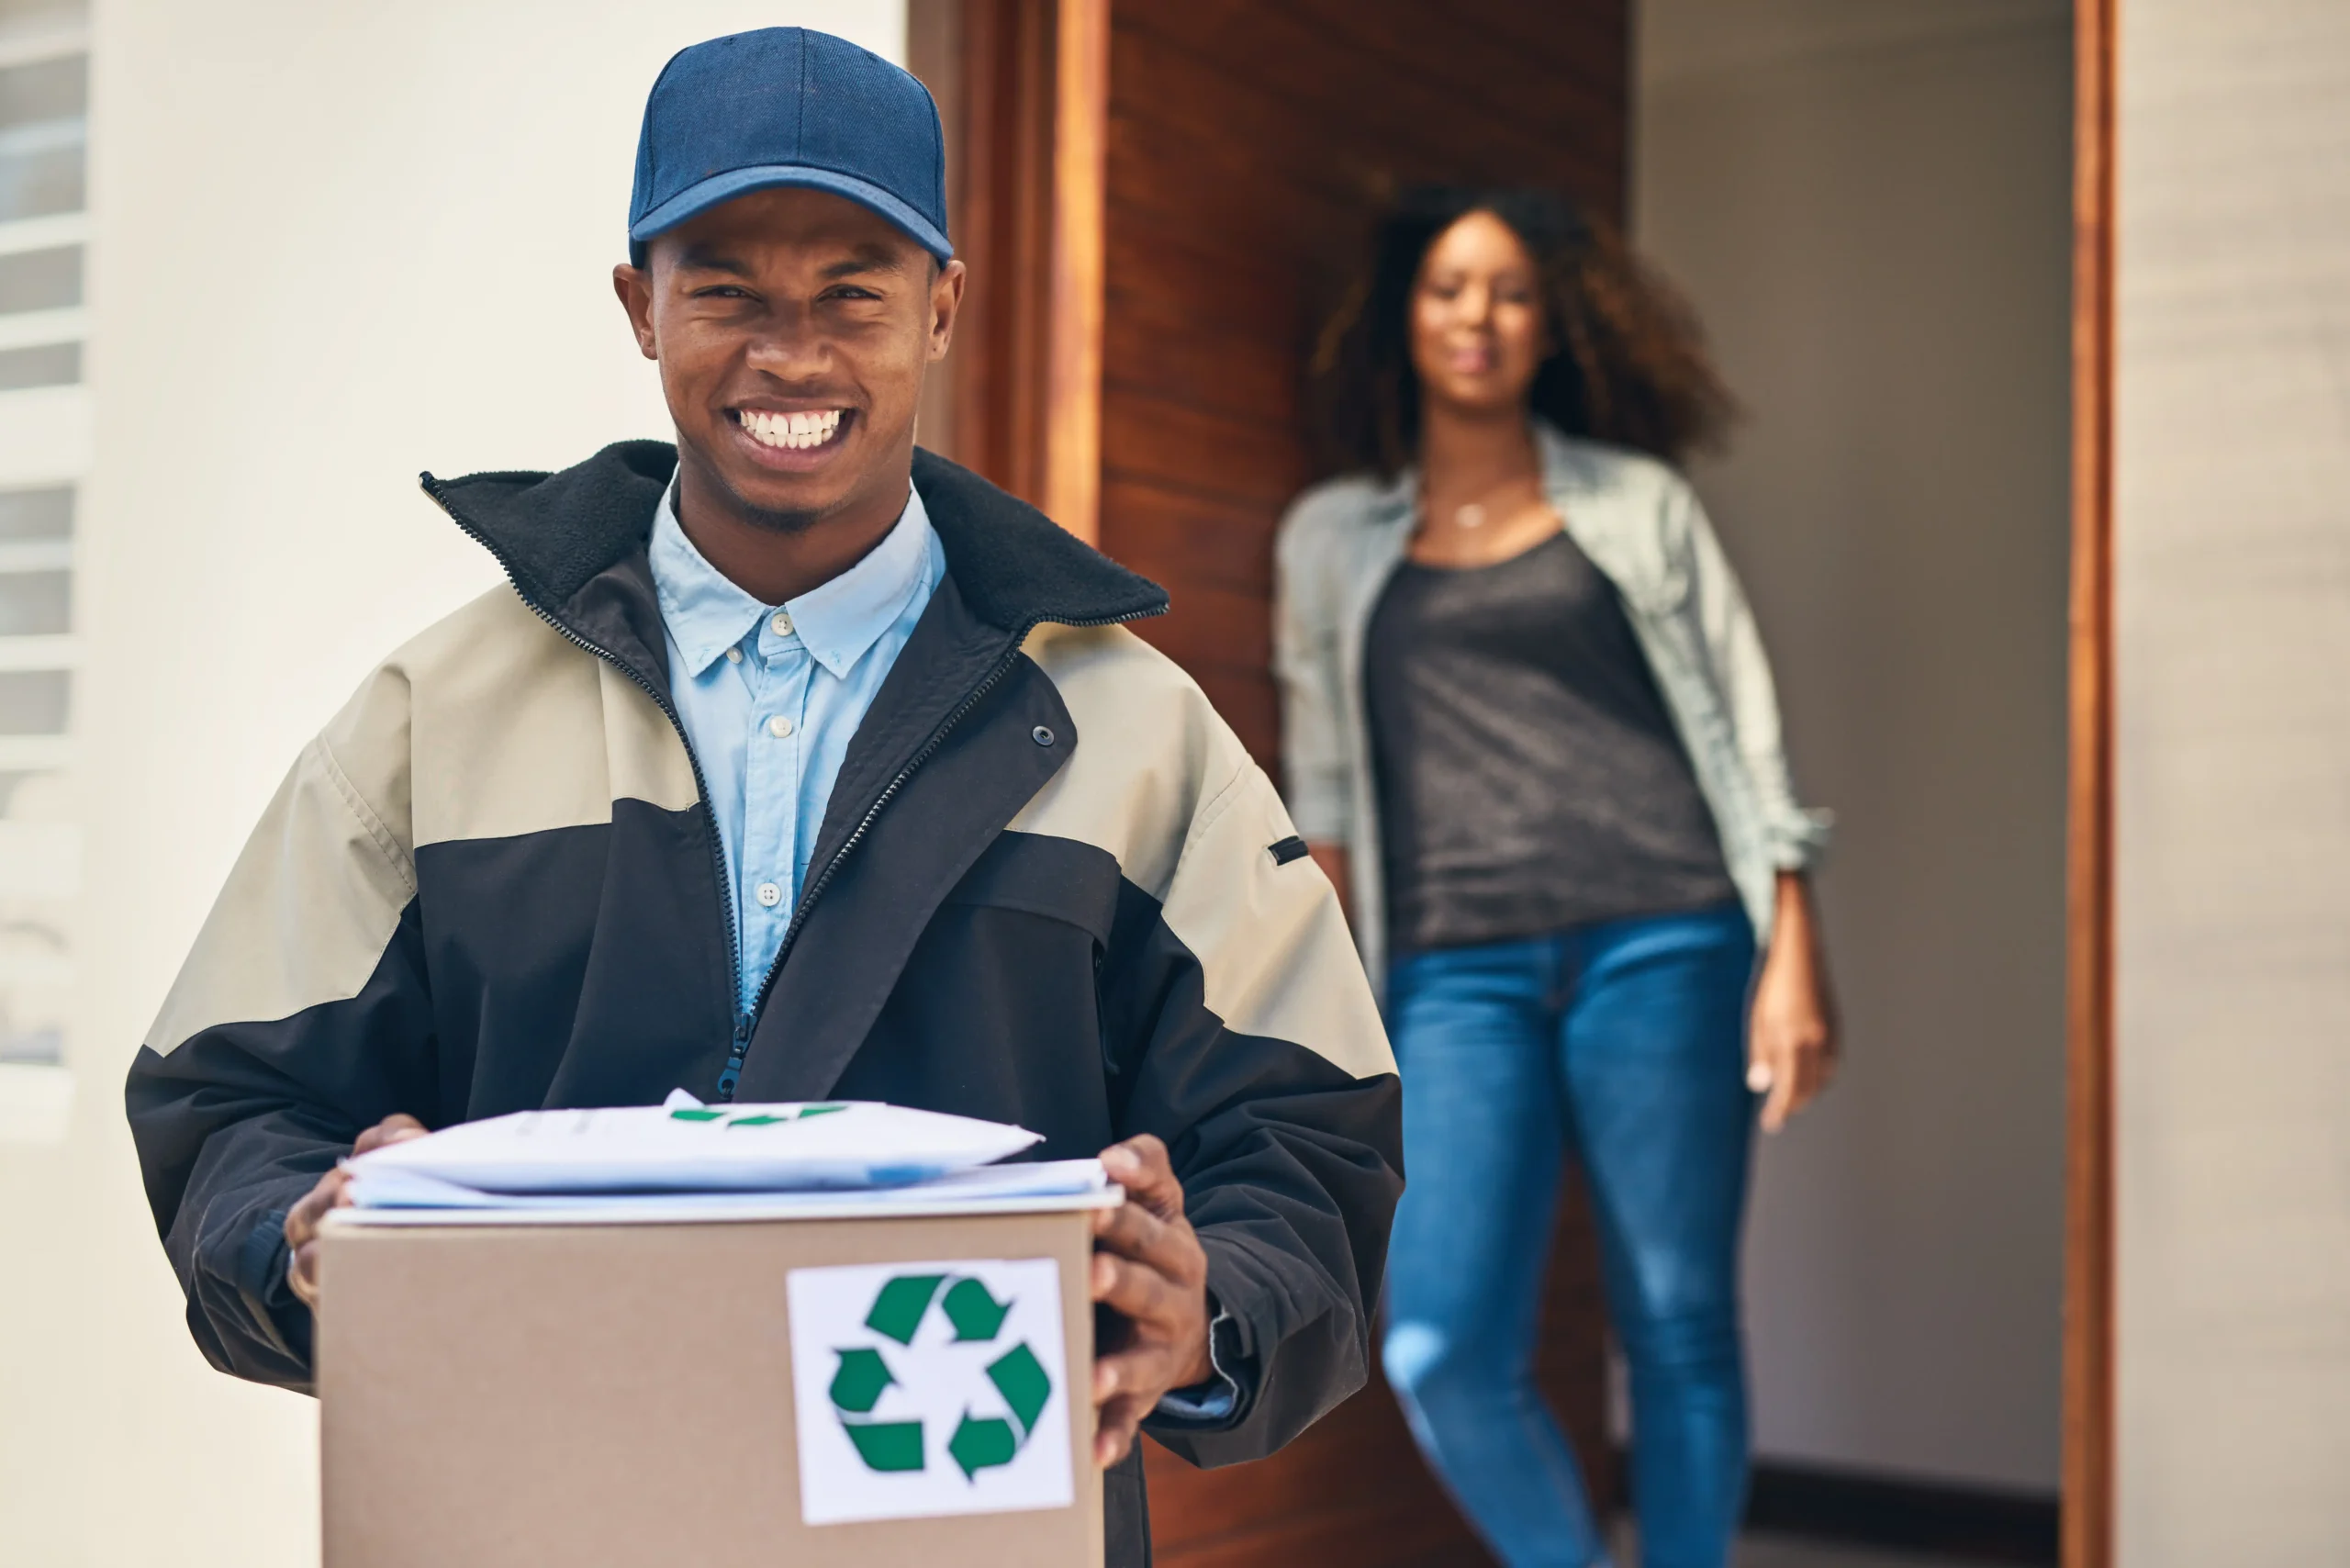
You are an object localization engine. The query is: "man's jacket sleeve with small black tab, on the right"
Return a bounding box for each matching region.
[1102,731,1403,1464]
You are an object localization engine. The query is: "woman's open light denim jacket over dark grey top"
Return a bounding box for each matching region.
[1274,420,1829,978]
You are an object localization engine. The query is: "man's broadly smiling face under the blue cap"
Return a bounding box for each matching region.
[613,188,964,532]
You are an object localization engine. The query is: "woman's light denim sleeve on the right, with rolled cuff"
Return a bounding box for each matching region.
[1666,477,1833,872]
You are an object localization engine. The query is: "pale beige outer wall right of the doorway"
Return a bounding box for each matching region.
[2112,0,2350,1568]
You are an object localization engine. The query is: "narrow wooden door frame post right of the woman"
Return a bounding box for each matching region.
[2064,0,2120,1568]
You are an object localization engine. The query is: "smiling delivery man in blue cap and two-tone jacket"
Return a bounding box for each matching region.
[129,28,1403,1563]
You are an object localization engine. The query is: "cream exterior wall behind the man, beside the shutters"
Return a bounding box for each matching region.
[0,0,902,1568]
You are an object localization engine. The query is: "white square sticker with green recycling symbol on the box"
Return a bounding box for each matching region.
[785,1258,1076,1523]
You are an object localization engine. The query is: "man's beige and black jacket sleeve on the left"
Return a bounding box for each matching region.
[125,675,432,1387]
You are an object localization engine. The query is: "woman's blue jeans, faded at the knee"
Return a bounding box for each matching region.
[1382,905,1755,1568]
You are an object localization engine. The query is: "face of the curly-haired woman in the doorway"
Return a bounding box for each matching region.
[1410,211,1549,416]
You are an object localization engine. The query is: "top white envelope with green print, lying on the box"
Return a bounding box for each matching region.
[348,1093,1041,1196]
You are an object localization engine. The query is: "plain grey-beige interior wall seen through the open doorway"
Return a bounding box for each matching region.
[1633,0,2070,1493]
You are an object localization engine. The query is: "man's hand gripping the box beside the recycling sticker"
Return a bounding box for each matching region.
[1090,1133,1215,1467]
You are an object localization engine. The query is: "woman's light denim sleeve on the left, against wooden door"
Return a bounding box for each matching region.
[1274,491,1354,844]
